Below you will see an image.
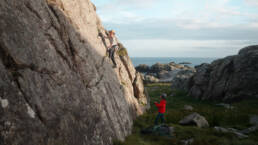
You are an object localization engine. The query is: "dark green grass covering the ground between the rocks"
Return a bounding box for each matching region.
[114,83,258,145]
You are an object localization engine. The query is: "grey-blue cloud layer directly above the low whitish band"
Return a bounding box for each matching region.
[107,19,258,40]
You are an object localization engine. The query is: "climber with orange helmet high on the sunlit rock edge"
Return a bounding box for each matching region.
[107,30,119,67]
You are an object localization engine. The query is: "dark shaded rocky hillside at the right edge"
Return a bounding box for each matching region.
[188,45,258,101]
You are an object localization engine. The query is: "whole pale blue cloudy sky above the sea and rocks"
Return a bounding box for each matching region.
[92,0,258,58]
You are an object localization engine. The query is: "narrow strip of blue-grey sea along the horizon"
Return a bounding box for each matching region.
[131,57,218,67]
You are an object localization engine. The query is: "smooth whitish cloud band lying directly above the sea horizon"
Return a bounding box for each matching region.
[123,39,257,57]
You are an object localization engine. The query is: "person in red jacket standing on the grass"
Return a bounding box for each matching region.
[155,93,167,125]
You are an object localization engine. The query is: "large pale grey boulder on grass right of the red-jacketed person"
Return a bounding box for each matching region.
[179,113,209,128]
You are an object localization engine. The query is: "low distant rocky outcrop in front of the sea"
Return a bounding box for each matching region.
[136,62,195,83]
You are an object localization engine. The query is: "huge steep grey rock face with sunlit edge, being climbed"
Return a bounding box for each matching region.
[0,0,147,145]
